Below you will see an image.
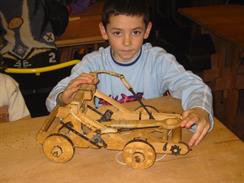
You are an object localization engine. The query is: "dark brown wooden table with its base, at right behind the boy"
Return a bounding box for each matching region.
[179,5,244,139]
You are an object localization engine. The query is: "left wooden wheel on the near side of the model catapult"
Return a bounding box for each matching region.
[43,134,74,163]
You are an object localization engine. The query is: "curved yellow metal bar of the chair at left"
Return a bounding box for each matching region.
[5,60,80,76]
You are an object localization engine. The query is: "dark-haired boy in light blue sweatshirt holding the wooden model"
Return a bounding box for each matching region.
[46,0,213,147]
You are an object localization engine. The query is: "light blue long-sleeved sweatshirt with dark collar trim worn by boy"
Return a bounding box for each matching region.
[46,43,213,128]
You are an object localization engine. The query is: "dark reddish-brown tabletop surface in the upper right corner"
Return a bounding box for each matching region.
[179,5,244,48]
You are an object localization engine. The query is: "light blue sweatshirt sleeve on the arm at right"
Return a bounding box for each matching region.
[157,54,214,130]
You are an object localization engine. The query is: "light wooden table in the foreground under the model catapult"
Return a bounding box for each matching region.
[0,117,244,183]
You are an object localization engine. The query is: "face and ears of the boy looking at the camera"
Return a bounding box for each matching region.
[99,15,152,62]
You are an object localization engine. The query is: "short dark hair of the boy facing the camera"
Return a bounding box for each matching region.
[102,0,150,27]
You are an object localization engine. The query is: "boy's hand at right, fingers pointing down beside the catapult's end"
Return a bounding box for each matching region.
[181,107,210,147]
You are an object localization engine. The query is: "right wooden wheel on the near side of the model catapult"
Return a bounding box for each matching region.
[123,141,156,169]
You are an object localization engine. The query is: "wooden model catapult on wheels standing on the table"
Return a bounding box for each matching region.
[37,71,189,169]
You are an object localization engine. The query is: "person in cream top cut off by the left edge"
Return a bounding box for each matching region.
[0,73,30,122]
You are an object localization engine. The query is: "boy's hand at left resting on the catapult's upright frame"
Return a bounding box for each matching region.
[58,73,98,104]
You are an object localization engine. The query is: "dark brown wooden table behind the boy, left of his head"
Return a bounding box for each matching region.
[56,0,104,62]
